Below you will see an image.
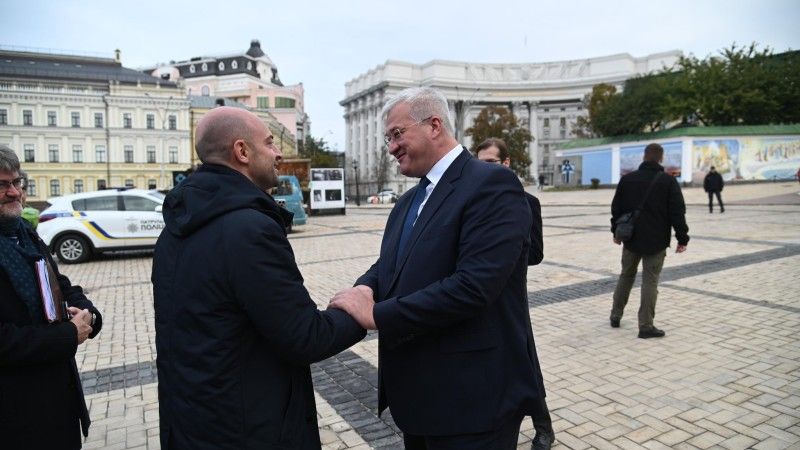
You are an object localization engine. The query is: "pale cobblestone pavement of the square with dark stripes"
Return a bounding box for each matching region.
[61,183,800,449]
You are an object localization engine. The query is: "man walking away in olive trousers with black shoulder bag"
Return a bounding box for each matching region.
[611,144,689,339]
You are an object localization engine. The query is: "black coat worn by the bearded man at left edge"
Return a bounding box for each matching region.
[0,220,103,449]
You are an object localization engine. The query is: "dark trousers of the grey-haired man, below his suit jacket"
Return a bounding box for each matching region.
[403,416,522,450]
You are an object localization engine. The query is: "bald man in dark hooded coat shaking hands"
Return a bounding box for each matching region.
[152,107,366,450]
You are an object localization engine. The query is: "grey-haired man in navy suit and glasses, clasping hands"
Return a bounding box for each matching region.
[331,88,544,449]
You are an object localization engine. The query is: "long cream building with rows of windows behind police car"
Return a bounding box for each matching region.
[0,50,192,201]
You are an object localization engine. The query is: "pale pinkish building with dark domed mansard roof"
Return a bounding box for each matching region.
[145,40,310,147]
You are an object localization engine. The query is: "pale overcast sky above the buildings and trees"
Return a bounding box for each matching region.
[0,0,800,150]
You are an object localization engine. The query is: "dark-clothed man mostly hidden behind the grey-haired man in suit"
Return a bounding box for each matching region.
[475,138,556,450]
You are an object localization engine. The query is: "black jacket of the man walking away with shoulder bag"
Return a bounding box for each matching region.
[611,162,689,255]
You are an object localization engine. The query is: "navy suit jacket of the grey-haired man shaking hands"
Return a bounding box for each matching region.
[357,150,544,436]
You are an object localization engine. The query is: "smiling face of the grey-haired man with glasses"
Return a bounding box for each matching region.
[383,103,441,178]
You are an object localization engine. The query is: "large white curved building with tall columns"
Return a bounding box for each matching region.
[340,51,682,195]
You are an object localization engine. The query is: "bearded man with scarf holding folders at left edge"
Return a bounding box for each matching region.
[0,145,102,450]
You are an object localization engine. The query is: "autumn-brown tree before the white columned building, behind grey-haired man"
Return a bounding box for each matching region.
[466,106,534,177]
